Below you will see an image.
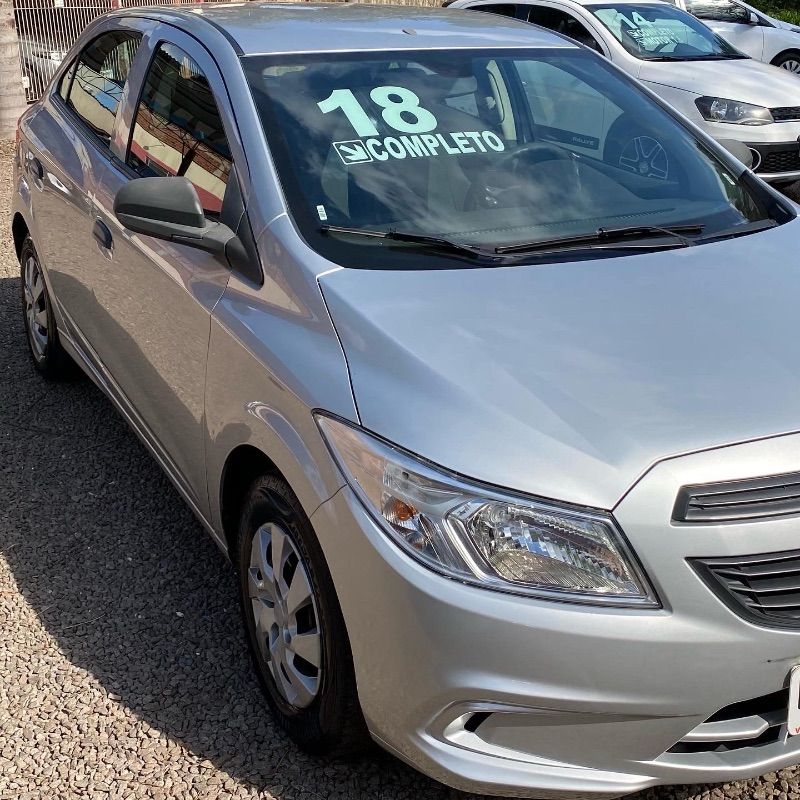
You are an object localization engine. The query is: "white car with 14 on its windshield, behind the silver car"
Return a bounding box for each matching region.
[448,0,800,184]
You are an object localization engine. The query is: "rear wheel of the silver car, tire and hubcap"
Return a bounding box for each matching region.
[19,236,80,381]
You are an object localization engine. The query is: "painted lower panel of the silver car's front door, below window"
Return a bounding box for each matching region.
[88,161,230,512]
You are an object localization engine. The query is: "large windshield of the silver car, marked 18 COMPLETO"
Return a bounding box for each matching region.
[244,47,786,269]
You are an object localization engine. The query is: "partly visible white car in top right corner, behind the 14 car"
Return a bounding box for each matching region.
[669,0,800,75]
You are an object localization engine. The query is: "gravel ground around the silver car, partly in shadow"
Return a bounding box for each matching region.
[0,133,800,800]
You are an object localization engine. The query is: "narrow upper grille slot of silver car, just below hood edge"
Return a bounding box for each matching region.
[672,472,800,524]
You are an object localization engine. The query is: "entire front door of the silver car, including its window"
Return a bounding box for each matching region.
[90,36,238,514]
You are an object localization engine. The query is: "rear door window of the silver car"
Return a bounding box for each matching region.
[65,31,141,145]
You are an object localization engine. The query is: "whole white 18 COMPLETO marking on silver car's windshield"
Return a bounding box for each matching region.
[317,86,505,165]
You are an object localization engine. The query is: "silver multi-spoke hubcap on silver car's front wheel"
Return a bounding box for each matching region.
[248,522,322,708]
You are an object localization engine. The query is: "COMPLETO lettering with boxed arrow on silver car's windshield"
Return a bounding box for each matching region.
[333,131,506,165]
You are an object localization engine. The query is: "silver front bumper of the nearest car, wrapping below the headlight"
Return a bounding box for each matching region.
[312,436,800,798]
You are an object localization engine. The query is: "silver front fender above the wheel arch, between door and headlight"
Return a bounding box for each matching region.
[206,222,359,548]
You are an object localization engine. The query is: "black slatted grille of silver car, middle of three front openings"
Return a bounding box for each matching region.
[690,550,800,628]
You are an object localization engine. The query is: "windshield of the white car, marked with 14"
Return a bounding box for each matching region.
[587,3,747,61]
